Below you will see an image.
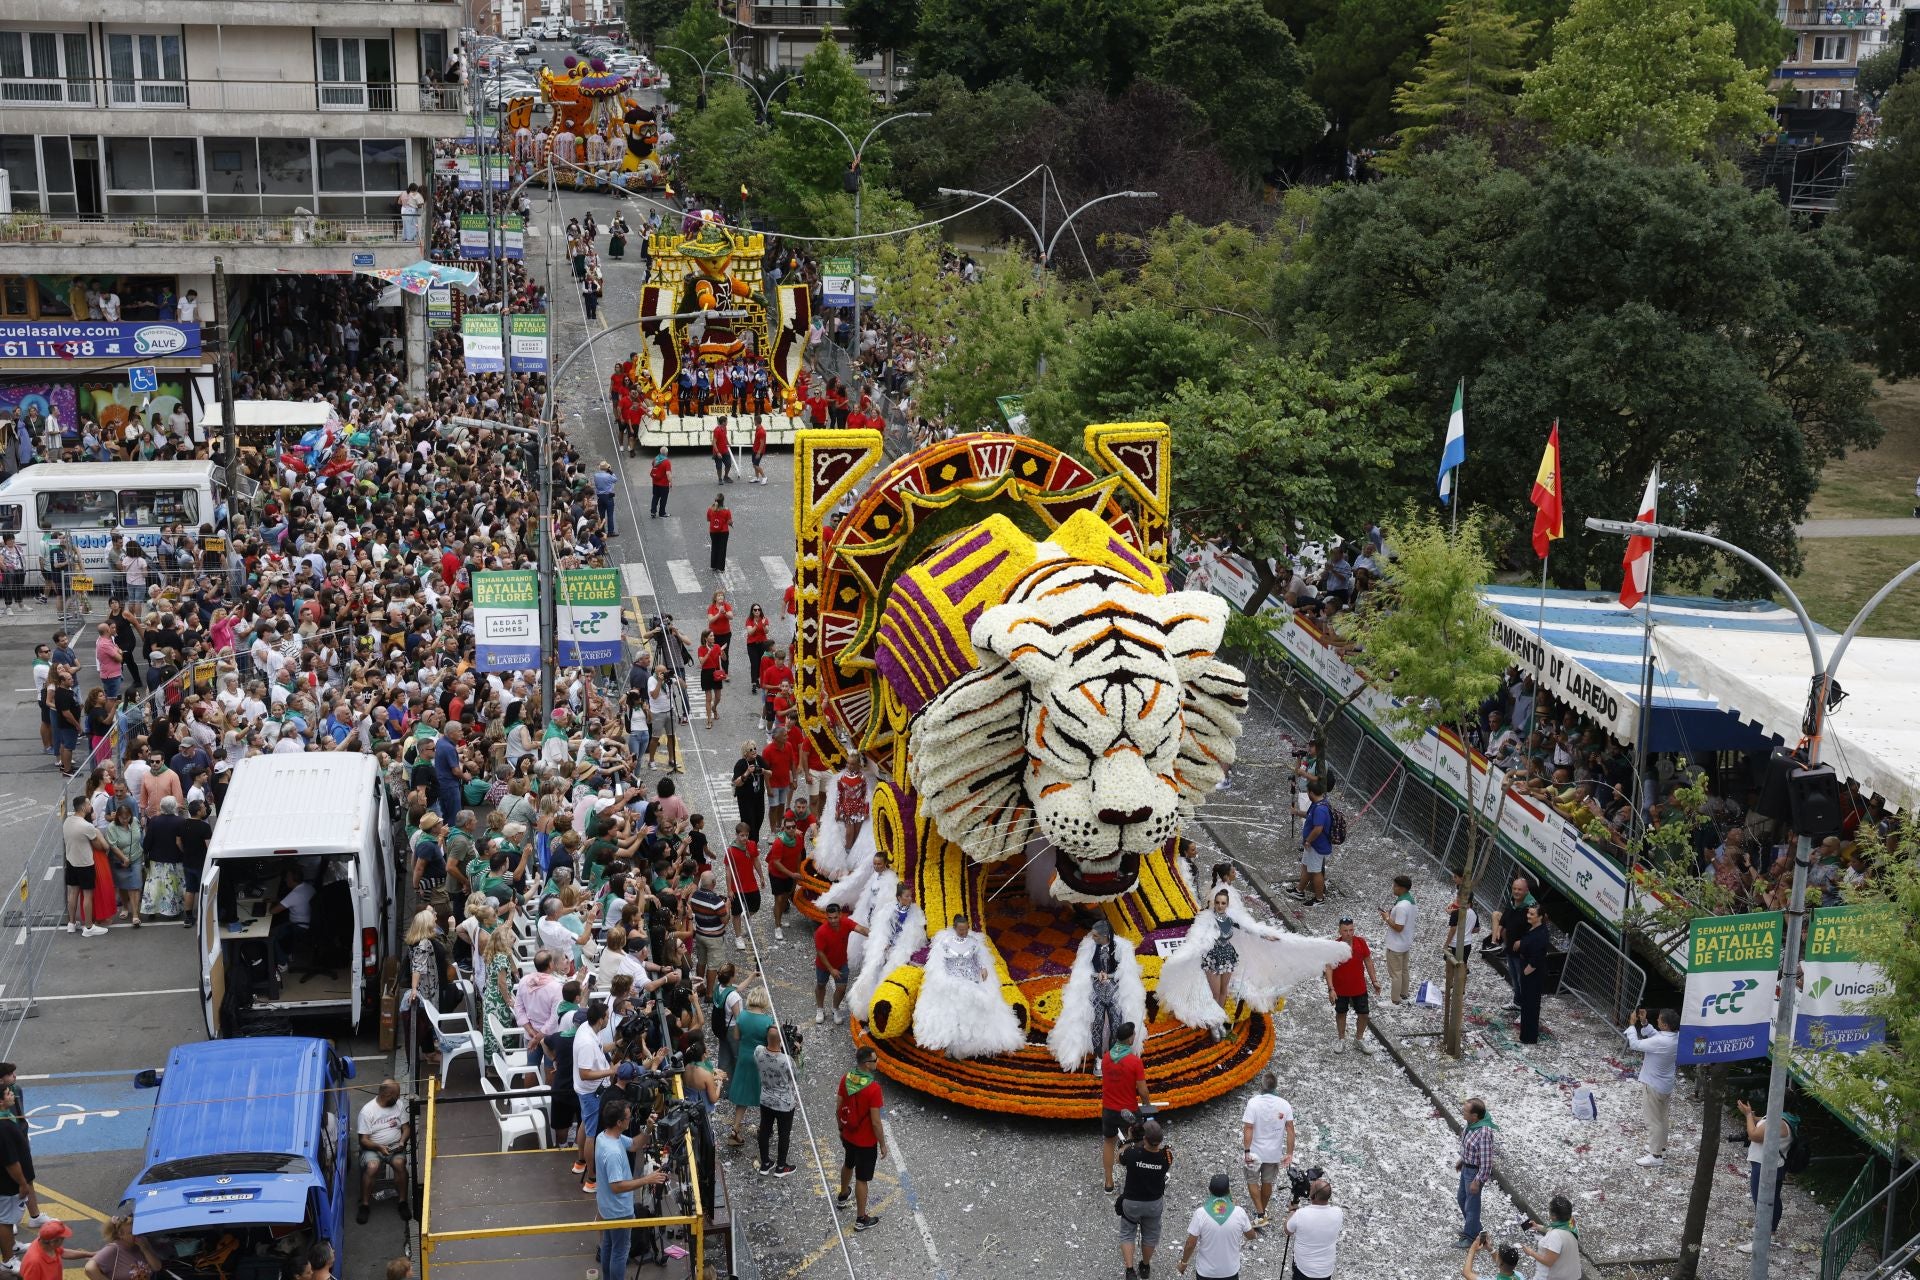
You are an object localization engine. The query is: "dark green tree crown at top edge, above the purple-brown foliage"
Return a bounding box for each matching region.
[914,0,1169,96]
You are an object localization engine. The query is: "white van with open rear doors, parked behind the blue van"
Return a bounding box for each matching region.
[200,750,403,1038]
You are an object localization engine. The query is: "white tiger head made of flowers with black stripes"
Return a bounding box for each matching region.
[908,543,1248,902]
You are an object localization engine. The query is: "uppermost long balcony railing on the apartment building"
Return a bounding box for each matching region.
[0,77,465,115]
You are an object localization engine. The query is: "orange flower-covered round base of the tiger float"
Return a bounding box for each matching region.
[793,862,1273,1121]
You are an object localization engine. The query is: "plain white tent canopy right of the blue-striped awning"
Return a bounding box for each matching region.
[1653,628,1920,812]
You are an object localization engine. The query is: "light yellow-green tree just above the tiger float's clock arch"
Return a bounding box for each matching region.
[920,253,1071,430]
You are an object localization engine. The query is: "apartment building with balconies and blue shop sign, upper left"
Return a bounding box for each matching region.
[0,0,467,401]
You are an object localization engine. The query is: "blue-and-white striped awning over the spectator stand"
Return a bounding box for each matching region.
[1480,587,1781,756]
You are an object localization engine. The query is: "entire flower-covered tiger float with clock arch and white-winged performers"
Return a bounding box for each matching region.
[793,422,1348,1117]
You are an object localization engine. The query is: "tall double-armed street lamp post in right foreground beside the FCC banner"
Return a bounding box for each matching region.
[1586,516,1920,1280]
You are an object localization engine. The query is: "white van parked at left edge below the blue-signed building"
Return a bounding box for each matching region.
[0,462,217,572]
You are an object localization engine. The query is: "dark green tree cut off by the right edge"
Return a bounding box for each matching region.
[1839,75,1920,378]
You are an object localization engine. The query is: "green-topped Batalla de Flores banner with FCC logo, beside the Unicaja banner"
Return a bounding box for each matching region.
[1680,912,1784,1063]
